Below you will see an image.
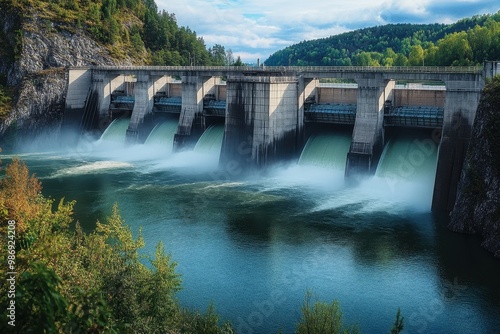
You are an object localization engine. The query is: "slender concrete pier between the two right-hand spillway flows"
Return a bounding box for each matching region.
[346,77,395,177]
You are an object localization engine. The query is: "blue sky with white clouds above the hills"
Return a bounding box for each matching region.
[156,0,500,63]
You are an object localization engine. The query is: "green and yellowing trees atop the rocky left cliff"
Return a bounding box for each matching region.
[0,0,231,65]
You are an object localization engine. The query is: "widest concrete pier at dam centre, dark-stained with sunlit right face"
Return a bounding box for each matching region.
[220,77,302,169]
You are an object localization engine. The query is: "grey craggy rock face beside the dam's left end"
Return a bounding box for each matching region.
[0,11,131,141]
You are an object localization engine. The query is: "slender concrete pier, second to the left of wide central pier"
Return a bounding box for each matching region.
[127,72,155,143]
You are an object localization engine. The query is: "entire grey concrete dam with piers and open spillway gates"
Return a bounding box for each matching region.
[63,62,500,211]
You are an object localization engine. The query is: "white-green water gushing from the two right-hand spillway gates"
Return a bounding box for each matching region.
[294,133,437,213]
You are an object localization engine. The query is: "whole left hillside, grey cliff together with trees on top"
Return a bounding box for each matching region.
[0,0,235,130]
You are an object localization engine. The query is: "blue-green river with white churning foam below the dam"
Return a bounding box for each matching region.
[2,127,500,333]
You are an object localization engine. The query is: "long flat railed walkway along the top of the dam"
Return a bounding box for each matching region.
[83,66,484,81]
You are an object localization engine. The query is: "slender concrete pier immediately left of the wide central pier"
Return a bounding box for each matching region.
[174,73,215,151]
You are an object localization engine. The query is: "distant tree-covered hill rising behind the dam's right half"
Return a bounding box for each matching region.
[265,11,500,66]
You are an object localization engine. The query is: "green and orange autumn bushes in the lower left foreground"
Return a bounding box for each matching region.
[0,159,232,333]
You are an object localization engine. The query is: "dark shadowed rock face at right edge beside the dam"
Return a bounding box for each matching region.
[449,76,500,258]
